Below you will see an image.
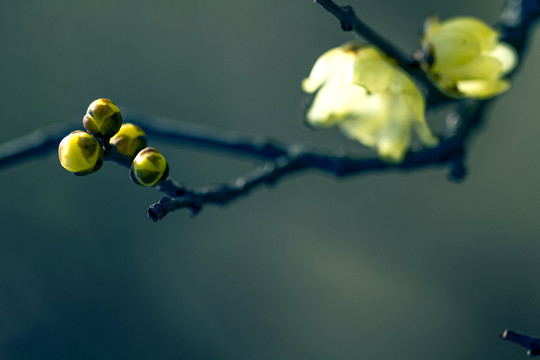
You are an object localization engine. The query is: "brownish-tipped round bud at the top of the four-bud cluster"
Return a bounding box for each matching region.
[83,99,122,138]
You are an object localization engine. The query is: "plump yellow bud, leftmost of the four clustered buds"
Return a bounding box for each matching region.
[58,130,103,175]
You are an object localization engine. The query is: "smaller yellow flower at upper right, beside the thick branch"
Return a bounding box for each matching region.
[422,17,518,99]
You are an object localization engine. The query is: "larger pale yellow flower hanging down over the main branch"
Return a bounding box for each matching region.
[302,41,438,163]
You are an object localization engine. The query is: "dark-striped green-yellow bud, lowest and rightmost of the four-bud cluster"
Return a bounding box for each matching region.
[129,147,169,186]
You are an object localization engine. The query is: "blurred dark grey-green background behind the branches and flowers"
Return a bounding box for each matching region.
[0,0,540,360]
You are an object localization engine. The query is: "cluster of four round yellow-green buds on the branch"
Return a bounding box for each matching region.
[58,99,169,186]
